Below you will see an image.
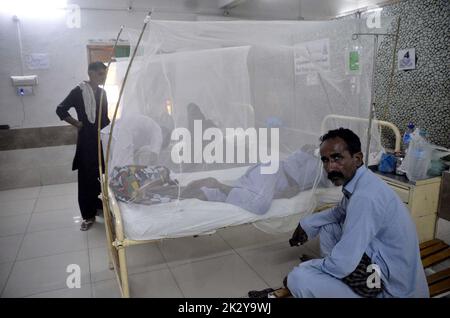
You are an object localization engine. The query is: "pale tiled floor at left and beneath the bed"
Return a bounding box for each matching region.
[0,183,318,297]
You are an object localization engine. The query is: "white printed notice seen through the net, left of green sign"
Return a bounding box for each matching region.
[294,39,330,75]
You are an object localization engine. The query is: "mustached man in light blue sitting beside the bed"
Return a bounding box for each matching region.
[287,128,429,297]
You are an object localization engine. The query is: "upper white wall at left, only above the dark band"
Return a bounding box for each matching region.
[0,0,221,128]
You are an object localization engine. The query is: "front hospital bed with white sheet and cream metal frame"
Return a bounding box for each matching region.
[104,167,342,297]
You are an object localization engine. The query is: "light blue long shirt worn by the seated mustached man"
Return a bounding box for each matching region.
[300,166,429,297]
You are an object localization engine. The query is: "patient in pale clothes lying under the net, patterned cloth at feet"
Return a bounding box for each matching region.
[111,150,329,215]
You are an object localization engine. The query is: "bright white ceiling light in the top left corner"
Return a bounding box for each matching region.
[0,0,67,19]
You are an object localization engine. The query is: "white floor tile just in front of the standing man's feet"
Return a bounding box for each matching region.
[17,228,87,260]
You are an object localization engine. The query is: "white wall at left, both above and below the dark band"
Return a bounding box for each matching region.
[0,0,222,190]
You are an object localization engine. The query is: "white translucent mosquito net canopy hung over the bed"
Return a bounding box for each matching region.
[104,19,391,221]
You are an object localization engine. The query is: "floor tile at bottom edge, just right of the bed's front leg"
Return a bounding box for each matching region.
[129,269,183,298]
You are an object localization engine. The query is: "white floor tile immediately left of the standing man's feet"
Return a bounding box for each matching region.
[27,210,82,232]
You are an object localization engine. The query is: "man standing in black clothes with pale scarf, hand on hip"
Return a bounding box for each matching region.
[56,62,109,231]
